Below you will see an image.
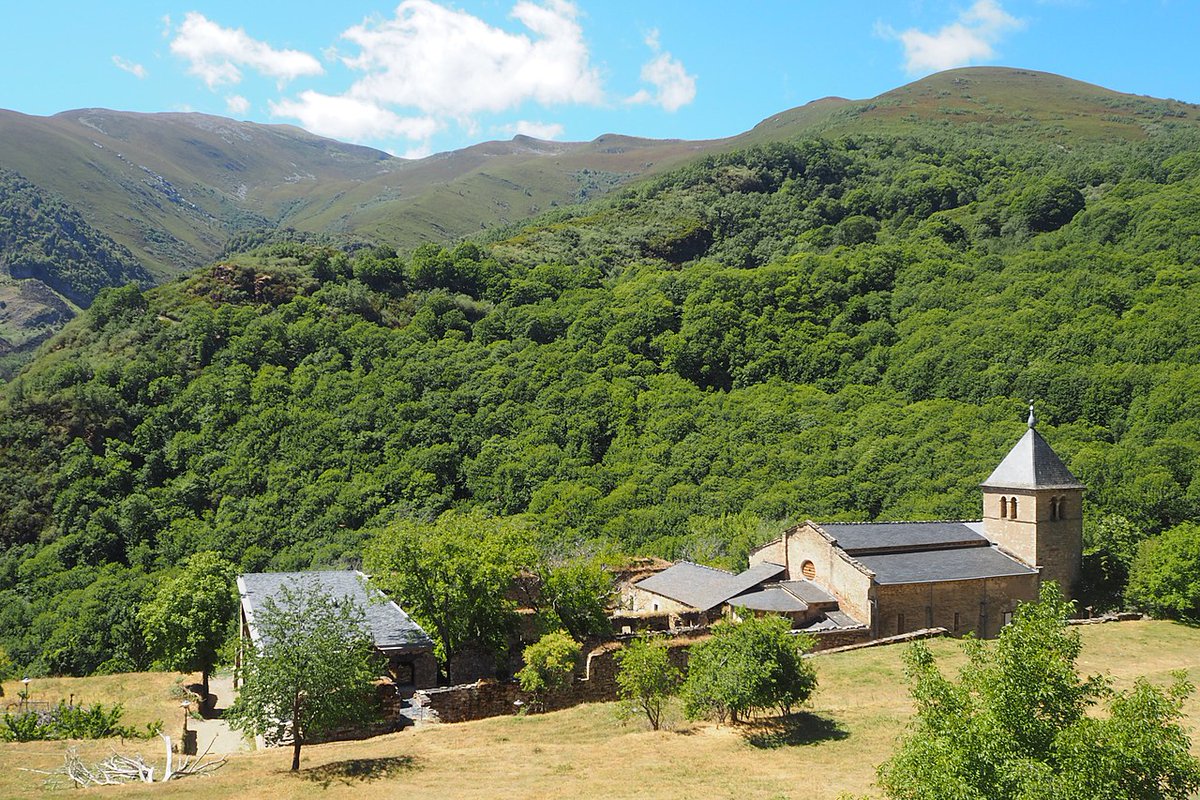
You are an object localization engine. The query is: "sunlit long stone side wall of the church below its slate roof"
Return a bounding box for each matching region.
[872,575,1038,638]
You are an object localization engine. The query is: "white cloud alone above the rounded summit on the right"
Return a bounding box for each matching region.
[881,0,1025,74]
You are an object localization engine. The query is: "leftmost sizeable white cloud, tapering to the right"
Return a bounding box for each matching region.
[170,11,324,89]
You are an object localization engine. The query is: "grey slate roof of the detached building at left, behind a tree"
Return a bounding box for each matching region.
[238,570,433,652]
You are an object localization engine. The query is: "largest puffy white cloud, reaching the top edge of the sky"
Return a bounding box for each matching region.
[342,0,602,120]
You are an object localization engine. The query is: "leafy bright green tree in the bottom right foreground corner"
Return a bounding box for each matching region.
[880,583,1200,800]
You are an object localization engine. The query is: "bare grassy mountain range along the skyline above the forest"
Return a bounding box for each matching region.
[0,68,1196,357]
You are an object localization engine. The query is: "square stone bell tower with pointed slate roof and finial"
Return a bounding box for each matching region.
[980,403,1084,597]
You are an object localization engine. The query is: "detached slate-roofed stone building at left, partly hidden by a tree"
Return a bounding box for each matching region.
[238,570,438,696]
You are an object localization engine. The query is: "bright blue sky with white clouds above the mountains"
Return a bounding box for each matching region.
[0,0,1200,156]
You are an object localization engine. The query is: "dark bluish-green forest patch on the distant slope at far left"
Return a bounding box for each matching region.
[0,169,150,307]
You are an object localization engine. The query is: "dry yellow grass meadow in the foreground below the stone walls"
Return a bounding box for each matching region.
[0,622,1200,800]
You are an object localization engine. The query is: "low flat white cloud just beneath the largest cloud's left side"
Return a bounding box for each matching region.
[269,91,442,142]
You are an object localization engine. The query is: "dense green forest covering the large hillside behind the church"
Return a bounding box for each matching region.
[0,113,1200,673]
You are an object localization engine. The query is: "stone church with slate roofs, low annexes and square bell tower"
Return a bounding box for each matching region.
[631,405,1084,638]
